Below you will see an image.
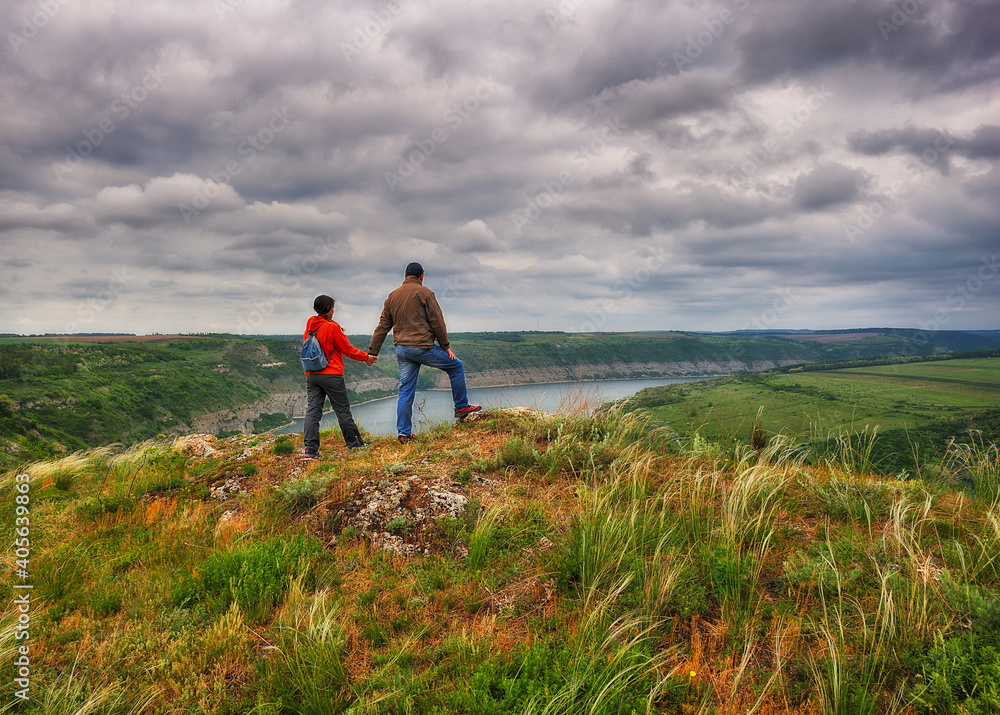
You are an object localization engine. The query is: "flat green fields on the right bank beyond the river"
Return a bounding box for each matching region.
[628,357,1000,472]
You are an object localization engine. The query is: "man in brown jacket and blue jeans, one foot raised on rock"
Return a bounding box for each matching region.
[368,262,482,443]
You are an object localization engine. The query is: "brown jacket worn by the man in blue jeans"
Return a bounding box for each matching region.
[368,276,449,355]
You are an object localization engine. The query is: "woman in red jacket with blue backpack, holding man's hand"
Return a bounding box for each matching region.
[302,295,377,459]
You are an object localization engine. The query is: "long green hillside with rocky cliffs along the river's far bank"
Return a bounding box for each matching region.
[0,328,1000,466]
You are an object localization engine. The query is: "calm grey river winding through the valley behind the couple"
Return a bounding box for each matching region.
[271,377,708,437]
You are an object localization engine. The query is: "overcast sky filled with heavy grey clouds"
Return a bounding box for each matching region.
[0,0,1000,334]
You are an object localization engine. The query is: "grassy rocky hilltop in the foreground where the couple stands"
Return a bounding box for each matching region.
[0,410,1000,715]
